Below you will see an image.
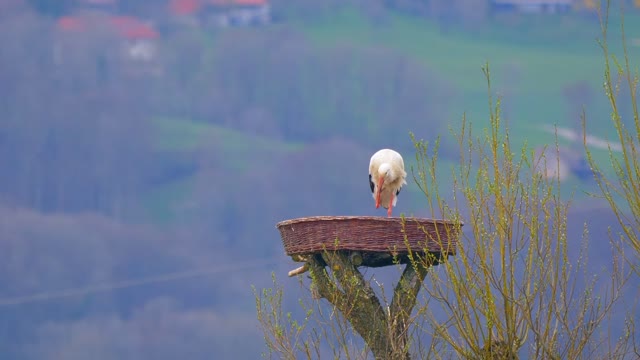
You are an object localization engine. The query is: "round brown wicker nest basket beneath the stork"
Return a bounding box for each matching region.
[276,216,463,267]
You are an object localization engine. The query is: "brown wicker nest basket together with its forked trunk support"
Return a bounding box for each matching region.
[276,216,463,360]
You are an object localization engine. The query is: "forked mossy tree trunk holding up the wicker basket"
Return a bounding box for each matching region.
[301,251,432,360]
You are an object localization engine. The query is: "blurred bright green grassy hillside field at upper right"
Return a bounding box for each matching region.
[299,11,640,144]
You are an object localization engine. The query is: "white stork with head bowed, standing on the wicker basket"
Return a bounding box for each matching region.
[369,149,407,217]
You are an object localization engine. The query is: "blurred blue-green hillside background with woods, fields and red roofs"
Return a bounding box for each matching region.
[0,0,640,359]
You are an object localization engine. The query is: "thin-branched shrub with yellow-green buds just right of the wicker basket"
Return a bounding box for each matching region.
[410,67,625,359]
